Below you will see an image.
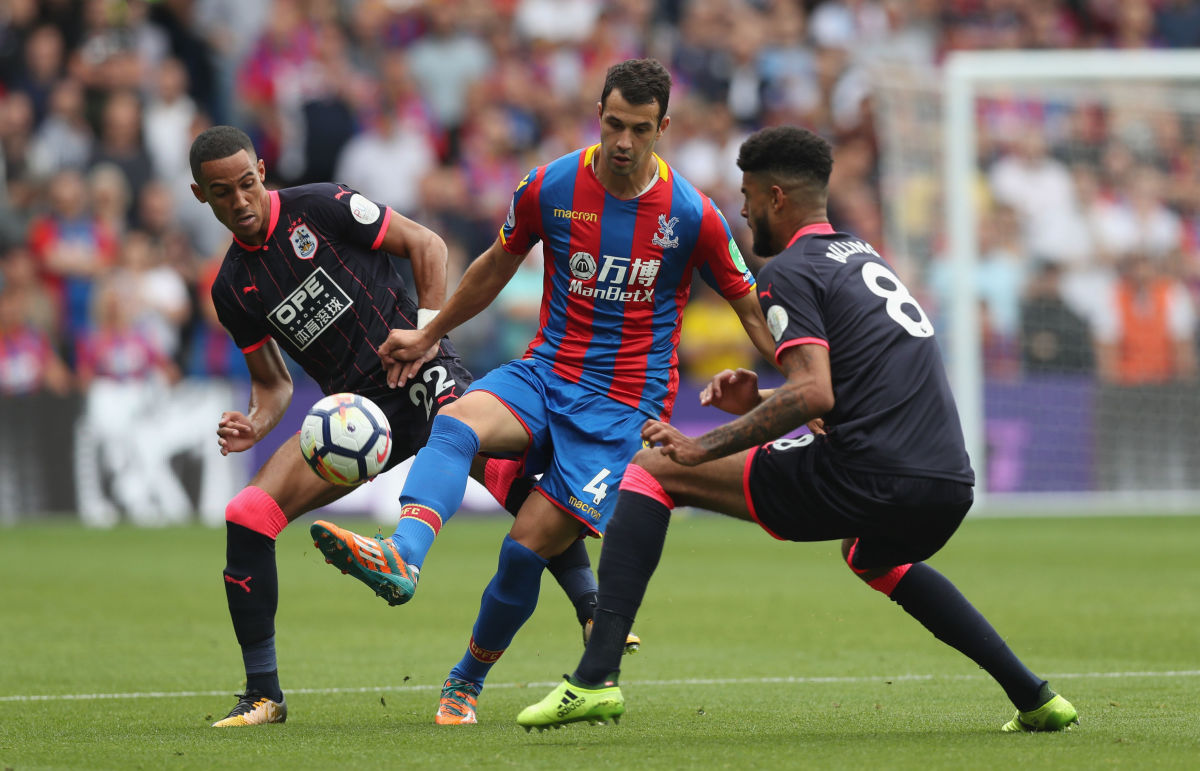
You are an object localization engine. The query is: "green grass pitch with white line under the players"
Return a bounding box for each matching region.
[0,515,1200,770]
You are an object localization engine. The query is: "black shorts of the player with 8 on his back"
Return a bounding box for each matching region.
[745,435,974,569]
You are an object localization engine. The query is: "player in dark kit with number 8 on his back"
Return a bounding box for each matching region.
[517,126,1078,731]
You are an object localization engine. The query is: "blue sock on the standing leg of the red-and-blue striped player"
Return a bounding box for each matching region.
[450,536,546,688]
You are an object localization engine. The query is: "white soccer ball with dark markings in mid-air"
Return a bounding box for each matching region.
[300,394,391,485]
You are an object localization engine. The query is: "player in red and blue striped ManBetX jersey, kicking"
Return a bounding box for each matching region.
[312,59,772,724]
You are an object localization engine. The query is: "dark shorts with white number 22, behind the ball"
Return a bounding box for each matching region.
[370,358,474,473]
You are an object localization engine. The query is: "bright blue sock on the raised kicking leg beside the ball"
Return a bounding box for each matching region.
[391,416,479,568]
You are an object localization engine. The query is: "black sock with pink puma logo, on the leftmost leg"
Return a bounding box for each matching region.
[223,522,283,701]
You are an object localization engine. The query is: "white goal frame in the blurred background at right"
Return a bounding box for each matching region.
[876,50,1200,514]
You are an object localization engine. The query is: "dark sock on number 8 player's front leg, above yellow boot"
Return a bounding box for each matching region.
[575,490,671,683]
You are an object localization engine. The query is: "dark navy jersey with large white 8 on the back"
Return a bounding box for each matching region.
[758,225,974,484]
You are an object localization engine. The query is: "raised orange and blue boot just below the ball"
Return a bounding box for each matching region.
[308,520,420,605]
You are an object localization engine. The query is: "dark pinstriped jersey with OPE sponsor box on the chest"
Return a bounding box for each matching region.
[212,183,457,396]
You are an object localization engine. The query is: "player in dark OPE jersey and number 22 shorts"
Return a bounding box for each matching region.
[191,126,614,727]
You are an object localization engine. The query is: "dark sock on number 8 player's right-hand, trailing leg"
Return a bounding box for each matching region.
[890,562,1049,712]
